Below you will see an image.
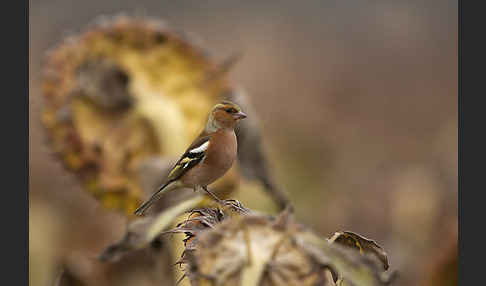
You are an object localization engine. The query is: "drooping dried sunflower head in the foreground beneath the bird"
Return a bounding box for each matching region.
[170,204,387,286]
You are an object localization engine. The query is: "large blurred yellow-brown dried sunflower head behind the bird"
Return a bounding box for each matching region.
[42,17,238,214]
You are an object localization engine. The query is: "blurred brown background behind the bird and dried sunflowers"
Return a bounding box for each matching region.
[29,0,458,285]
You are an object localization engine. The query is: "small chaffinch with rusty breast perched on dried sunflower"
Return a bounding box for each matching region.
[134,100,247,215]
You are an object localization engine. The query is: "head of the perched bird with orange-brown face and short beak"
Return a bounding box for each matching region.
[207,101,246,131]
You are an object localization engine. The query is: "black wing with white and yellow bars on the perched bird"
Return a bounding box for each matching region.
[168,134,211,181]
